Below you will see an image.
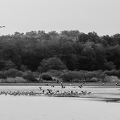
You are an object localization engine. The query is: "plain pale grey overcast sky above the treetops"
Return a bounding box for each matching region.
[0,0,120,35]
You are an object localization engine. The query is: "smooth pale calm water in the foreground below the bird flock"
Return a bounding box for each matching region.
[0,96,120,120]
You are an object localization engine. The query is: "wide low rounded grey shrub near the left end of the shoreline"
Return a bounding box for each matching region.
[4,68,23,78]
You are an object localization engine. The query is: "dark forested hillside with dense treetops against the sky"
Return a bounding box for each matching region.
[0,30,120,71]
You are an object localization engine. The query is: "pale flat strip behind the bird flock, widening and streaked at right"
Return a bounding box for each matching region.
[0,86,120,102]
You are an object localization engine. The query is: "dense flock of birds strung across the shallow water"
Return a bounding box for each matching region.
[0,83,91,97]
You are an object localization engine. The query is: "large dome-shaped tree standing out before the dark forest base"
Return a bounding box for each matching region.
[38,57,67,72]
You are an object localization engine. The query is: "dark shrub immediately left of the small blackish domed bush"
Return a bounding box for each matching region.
[23,71,37,82]
